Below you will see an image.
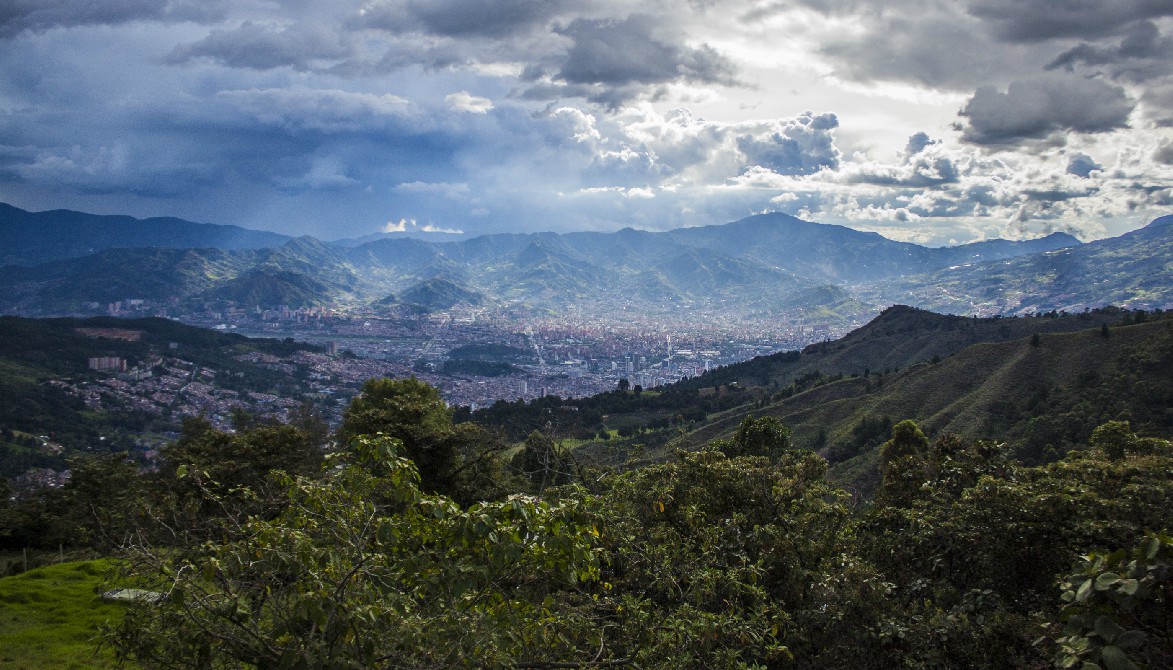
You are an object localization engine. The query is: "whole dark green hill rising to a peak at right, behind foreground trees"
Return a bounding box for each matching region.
[461,306,1173,492]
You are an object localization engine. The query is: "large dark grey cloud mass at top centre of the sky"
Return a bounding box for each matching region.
[347,0,739,109]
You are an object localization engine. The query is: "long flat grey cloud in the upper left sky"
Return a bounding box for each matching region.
[167,21,351,70]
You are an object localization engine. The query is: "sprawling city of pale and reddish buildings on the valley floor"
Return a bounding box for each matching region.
[85,294,853,414]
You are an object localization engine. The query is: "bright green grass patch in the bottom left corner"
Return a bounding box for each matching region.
[0,561,126,670]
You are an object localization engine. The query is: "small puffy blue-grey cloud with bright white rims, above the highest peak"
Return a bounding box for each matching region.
[737,113,841,175]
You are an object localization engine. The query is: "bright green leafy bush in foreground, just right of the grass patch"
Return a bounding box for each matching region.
[108,436,610,669]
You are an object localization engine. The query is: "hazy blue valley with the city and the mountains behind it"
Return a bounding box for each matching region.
[0,205,1173,417]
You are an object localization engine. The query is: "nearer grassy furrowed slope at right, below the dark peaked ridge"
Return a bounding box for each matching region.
[686,319,1173,489]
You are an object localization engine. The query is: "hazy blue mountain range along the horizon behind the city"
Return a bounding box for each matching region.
[0,205,1173,320]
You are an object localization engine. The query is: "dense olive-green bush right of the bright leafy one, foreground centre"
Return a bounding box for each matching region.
[584,451,879,669]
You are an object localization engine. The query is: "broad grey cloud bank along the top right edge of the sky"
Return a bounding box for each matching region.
[807,0,1173,96]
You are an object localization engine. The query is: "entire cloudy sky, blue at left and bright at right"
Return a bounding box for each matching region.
[0,0,1173,245]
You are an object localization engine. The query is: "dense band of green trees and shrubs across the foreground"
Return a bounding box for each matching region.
[0,380,1173,669]
